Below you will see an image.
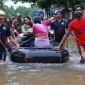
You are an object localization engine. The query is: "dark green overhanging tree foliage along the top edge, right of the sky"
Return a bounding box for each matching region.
[13,0,85,18]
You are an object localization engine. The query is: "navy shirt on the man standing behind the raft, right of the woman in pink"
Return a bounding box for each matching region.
[51,19,67,42]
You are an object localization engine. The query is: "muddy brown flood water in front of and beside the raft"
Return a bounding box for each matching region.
[0,36,85,85]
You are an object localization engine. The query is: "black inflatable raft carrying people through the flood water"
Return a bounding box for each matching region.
[7,47,69,63]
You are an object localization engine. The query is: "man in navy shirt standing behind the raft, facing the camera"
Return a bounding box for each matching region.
[51,11,67,45]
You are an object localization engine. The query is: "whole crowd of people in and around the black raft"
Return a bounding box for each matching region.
[0,5,85,63]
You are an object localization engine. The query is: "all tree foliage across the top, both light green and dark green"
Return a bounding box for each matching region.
[0,0,85,18]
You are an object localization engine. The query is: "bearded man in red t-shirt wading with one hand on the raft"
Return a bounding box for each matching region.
[57,5,85,63]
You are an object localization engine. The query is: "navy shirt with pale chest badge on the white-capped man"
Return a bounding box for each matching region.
[0,24,11,53]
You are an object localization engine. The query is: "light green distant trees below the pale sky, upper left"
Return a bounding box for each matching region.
[2,4,38,19]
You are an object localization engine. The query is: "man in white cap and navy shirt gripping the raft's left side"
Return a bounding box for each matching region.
[0,10,19,62]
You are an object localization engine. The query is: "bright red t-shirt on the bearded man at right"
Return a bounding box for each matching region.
[68,17,85,45]
